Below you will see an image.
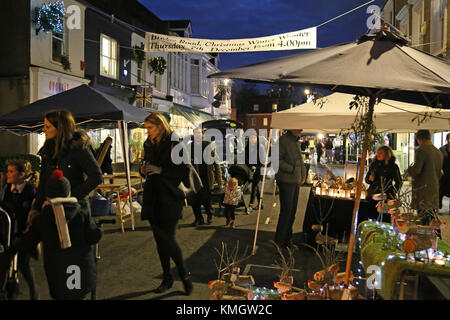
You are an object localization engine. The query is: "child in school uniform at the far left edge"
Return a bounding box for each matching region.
[0,160,39,300]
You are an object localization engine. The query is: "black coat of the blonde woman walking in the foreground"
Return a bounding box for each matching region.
[141,135,189,225]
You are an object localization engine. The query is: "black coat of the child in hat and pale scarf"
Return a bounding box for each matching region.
[14,203,102,300]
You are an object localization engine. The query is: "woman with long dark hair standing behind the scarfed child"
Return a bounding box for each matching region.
[28,110,102,223]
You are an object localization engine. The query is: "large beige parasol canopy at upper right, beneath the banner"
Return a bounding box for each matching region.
[209,30,450,108]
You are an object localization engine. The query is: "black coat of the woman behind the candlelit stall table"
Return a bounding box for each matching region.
[366,158,402,198]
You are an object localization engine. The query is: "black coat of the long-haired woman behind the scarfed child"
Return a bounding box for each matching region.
[33,130,103,211]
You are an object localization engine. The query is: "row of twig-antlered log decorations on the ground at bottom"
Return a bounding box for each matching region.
[209,240,361,300]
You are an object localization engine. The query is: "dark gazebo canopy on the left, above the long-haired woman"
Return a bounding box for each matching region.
[0,85,150,133]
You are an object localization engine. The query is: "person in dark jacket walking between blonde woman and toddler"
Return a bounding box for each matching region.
[191,128,223,226]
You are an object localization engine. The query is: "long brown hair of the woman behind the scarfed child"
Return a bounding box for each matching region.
[44,110,76,158]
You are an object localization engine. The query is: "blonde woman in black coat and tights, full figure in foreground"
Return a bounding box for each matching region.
[140,112,193,295]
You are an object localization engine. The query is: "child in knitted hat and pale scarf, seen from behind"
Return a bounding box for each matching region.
[2,170,102,300]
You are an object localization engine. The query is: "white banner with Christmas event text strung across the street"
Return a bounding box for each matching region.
[145,27,317,53]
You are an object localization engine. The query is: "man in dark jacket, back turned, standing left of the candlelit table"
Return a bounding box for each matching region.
[275,130,306,248]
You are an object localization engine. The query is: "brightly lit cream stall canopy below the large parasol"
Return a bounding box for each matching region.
[271,93,450,133]
